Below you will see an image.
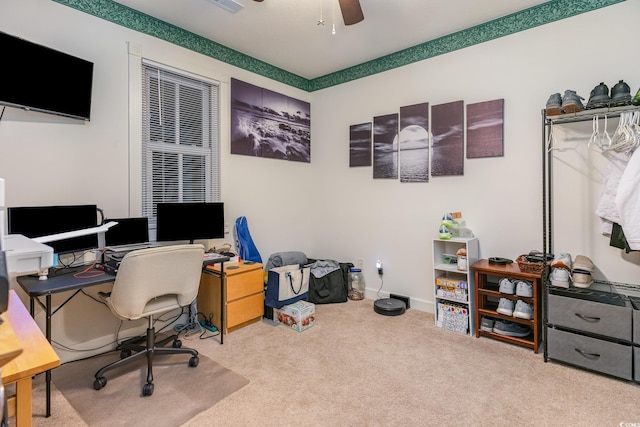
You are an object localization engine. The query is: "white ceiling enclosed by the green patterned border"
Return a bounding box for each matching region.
[116,0,545,79]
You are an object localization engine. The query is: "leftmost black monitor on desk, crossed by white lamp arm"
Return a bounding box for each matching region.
[7,205,98,254]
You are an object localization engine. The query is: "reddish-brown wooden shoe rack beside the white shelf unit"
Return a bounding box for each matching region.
[471,259,542,353]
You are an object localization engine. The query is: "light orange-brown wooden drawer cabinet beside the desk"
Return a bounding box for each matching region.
[198,261,264,334]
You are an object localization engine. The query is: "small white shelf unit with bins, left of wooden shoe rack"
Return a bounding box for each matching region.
[433,237,478,336]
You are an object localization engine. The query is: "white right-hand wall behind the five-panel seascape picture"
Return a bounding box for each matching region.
[312,2,640,311]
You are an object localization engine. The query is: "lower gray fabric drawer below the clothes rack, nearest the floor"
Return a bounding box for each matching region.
[547,328,633,380]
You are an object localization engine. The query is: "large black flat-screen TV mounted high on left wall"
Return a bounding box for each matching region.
[0,32,93,120]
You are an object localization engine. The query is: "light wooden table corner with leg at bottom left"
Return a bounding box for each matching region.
[0,290,60,427]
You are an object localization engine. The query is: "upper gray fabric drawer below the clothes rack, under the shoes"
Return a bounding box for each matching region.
[549,295,633,342]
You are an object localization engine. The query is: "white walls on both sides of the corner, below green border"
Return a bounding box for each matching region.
[0,0,640,360]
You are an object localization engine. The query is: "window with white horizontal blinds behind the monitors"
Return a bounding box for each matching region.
[142,61,221,227]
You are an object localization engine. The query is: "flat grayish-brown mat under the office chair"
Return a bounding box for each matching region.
[52,352,249,426]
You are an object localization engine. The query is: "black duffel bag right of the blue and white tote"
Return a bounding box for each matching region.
[307,260,353,304]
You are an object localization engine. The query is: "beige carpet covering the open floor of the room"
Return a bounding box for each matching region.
[16,300,640,427]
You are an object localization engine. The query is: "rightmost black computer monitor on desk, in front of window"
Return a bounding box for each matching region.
[156,202,224,243]
